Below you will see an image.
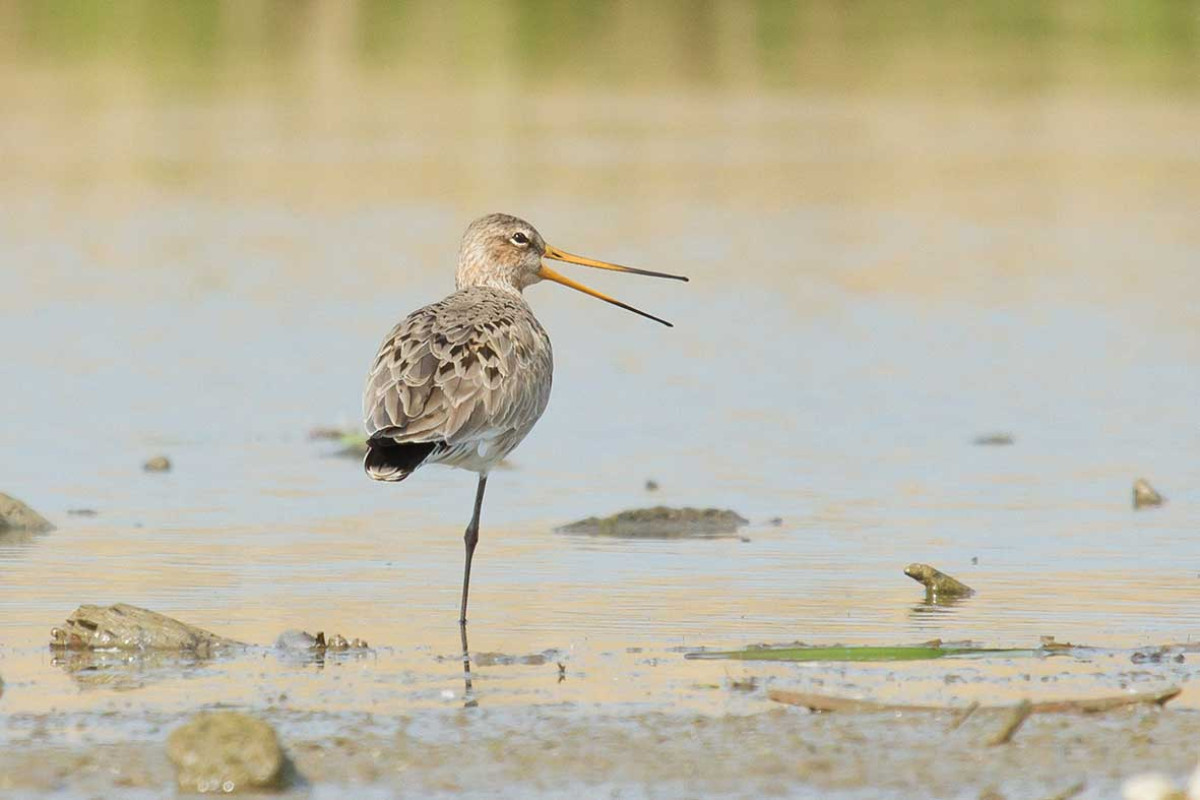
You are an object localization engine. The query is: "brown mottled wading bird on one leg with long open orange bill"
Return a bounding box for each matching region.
[362,213,688,625]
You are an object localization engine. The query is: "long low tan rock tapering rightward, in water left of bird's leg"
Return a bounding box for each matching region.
[50,603,245,657]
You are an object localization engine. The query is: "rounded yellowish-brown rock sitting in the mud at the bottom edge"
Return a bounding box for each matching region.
[167,711,287,794]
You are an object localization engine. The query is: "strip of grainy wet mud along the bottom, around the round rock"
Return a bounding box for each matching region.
[0,706,1200,798]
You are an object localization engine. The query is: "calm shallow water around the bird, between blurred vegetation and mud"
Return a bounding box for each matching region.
[0,4,1200,796]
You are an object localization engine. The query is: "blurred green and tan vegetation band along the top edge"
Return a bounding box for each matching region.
[0,0,1200,90]
